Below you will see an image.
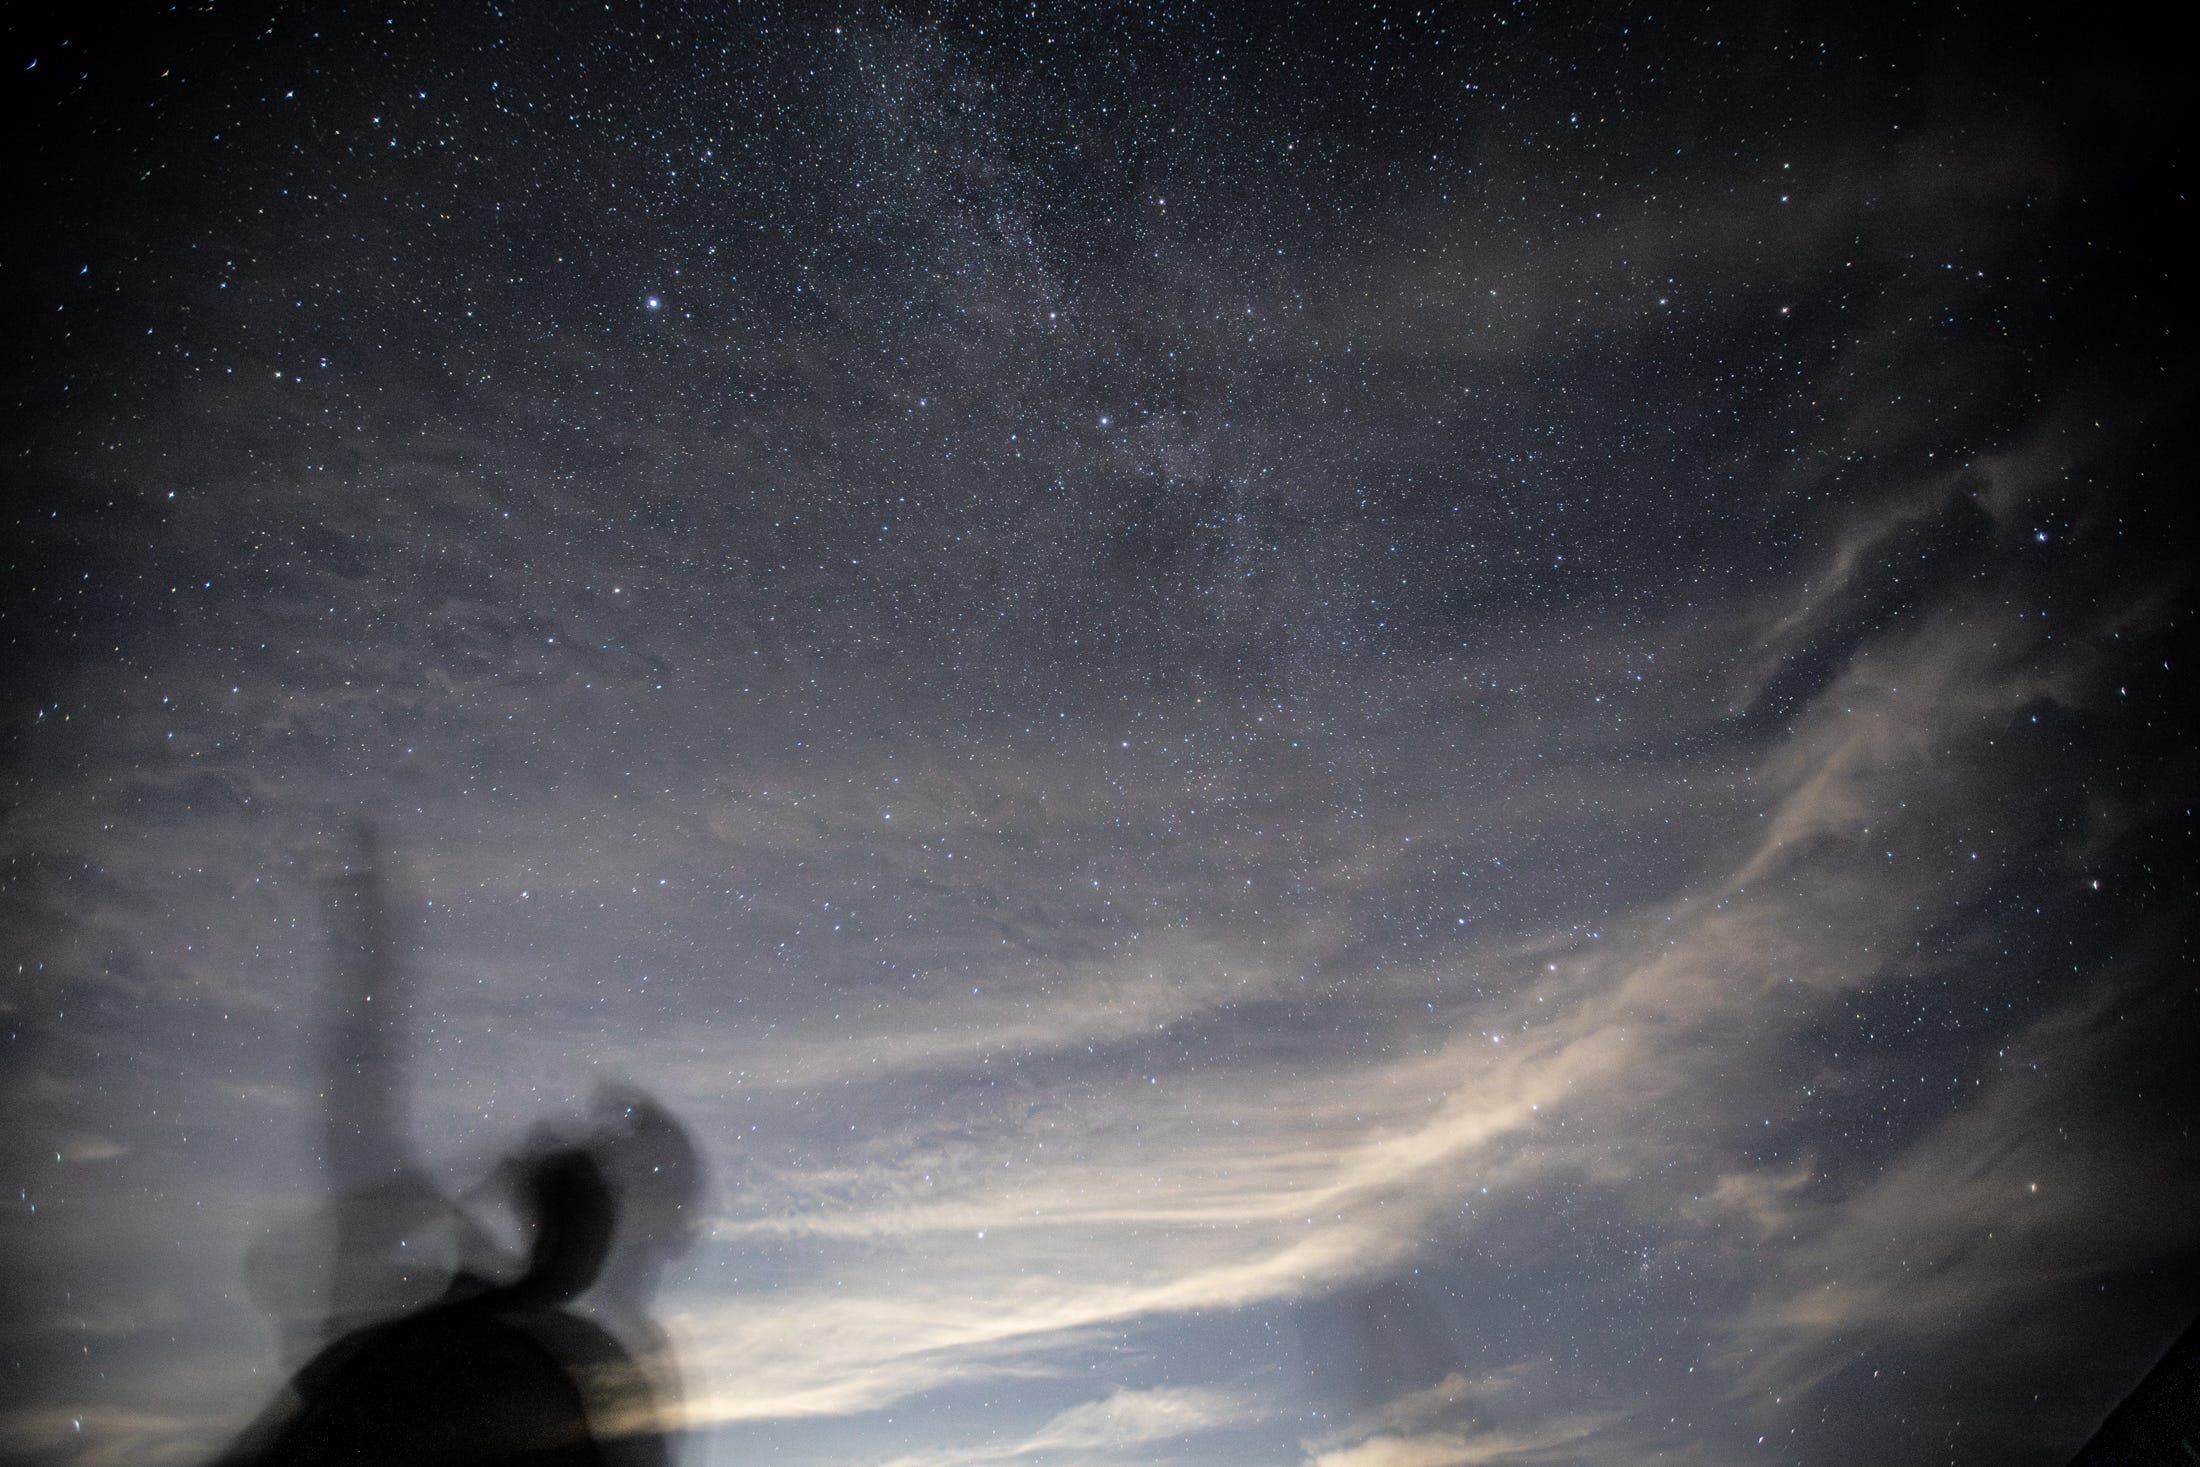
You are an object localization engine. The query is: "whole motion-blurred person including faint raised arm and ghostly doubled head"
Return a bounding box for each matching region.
[218,827,702,1467]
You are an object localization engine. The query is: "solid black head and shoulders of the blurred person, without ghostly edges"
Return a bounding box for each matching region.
[220,1150,669,1467]
